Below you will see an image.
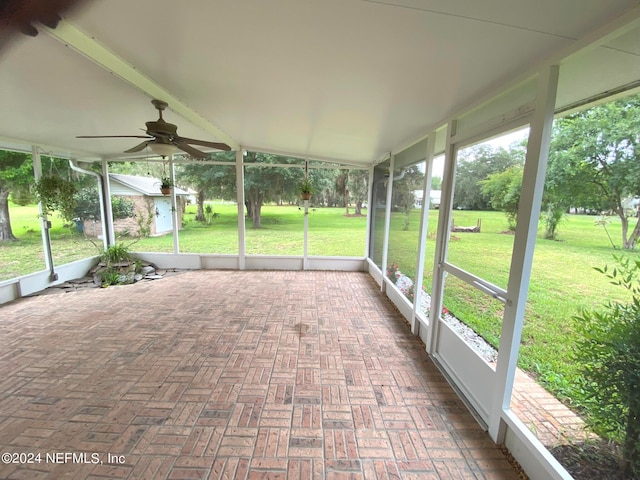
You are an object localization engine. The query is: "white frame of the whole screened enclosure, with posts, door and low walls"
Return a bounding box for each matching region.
[0,5,640,479]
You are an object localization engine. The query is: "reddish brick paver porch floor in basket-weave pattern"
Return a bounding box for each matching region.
[0,270,519,480]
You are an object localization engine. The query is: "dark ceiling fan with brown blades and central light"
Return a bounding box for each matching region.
[76,99,231,158]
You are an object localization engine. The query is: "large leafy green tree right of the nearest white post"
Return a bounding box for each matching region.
[546,95,640,249]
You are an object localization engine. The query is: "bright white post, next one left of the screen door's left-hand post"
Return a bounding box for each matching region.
[411,132,436,335]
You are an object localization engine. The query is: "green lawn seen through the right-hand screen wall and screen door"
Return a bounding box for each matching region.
[388,211,638,406]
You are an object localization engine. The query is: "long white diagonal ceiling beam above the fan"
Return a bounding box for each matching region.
[42,19,240,150]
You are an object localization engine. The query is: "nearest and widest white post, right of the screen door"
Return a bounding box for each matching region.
[489,65,559,443]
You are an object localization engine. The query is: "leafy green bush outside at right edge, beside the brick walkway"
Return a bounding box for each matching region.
[574,255,640,478]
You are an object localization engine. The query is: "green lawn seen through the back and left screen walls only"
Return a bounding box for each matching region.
[0,203,366,281]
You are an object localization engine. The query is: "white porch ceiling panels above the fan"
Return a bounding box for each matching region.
[0,0,640,165]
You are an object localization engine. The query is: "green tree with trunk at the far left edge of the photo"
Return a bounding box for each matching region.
[0,150,33,242]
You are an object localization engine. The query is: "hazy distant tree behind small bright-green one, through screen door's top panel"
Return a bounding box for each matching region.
[453,144,524,210]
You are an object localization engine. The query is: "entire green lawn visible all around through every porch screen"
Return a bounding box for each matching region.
[0,203,637,410]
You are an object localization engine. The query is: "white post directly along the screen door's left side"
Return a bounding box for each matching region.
[425,120,458,354]
